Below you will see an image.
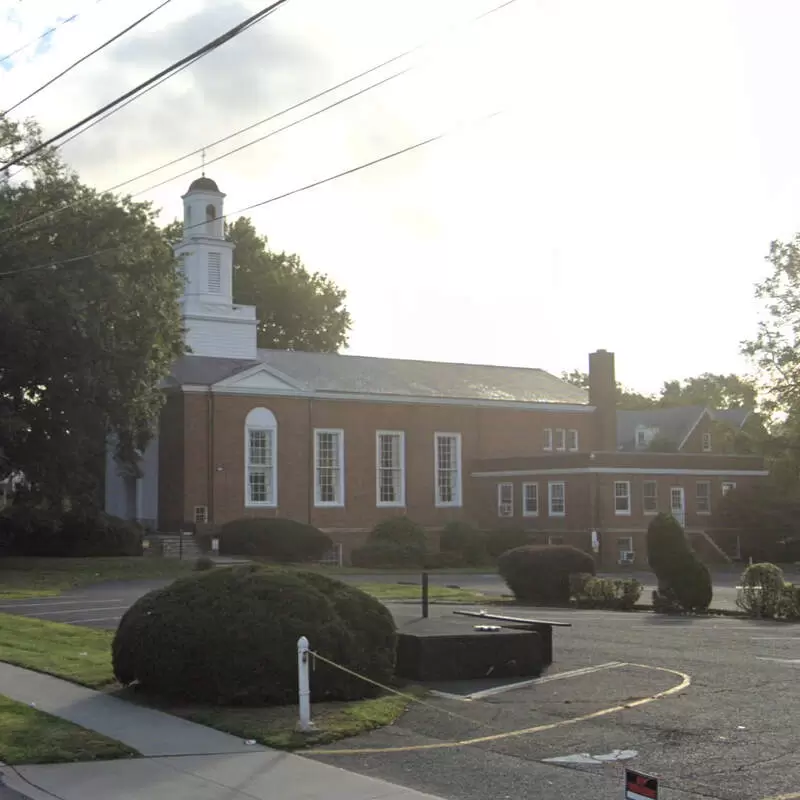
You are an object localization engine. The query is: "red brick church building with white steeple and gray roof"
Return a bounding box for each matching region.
[105,176,767,563]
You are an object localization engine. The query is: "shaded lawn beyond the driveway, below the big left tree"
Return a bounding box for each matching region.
[0,556,194,600]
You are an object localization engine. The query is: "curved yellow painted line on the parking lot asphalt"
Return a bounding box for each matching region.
[301,663,688,756]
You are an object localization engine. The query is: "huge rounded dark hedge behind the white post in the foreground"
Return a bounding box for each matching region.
[112,565,396,705]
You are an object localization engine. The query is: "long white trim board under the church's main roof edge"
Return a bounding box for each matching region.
[181,384,595,414]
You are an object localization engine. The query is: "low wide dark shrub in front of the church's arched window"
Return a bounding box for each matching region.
[219,517,333,564]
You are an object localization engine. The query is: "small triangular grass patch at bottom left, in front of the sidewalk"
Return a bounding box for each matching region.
[0,695,138,764]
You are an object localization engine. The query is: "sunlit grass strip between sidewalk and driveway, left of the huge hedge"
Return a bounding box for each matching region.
[0,614,114,688]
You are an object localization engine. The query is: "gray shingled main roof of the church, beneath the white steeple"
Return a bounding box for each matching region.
[172,350,588,404]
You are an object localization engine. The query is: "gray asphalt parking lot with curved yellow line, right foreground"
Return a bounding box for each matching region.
[312,606,800,800]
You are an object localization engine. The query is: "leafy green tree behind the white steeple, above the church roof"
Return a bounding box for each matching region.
[164,217,351,353]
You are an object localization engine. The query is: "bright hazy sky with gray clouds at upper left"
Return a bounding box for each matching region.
[0,0,800,392]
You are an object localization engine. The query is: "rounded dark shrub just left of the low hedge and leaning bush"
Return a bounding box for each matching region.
[497,545,595,605]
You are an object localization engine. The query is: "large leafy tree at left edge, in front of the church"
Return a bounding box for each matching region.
[0,118,184,507]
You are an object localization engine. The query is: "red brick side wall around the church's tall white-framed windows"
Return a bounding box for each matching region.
[161,393,592,530]
